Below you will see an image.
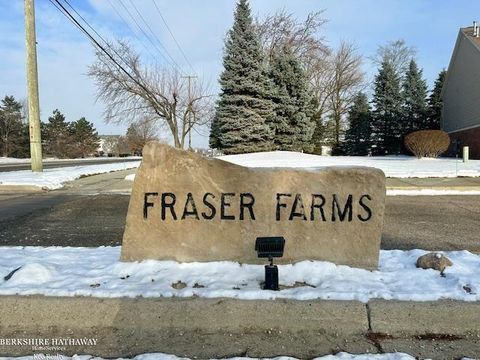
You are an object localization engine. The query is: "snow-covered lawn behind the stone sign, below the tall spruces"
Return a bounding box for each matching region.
[219,151,480,178]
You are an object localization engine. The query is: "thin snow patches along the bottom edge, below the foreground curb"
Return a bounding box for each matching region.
[0,353,415,360]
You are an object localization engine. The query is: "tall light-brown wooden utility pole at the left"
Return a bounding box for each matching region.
[25,0,43,172]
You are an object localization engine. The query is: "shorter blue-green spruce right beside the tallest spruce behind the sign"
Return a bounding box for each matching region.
[269,47,315,151]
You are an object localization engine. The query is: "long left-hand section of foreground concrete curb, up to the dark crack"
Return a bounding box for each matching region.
[0,296,375,358]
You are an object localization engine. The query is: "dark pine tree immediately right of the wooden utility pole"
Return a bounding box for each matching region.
[42,109,72,158]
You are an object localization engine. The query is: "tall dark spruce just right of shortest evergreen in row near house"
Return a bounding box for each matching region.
[372,61,402,155]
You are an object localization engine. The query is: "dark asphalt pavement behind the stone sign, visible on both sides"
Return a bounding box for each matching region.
[0,178,480,249]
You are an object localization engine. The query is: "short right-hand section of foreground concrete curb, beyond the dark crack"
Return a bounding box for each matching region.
[367,300,480,359]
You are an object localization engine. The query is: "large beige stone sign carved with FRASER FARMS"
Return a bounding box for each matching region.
[121,142,385,268]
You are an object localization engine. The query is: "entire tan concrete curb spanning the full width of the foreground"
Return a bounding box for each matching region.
[0,296,480,358]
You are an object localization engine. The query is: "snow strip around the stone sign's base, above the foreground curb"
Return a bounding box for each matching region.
[0,247,480,302]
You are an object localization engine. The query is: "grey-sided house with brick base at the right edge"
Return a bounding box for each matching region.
[441,22,480,159]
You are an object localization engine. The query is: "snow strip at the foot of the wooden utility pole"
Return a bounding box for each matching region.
[0,161,140,190]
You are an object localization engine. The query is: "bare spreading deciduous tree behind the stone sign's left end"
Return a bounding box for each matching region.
[88,41,213,148]
